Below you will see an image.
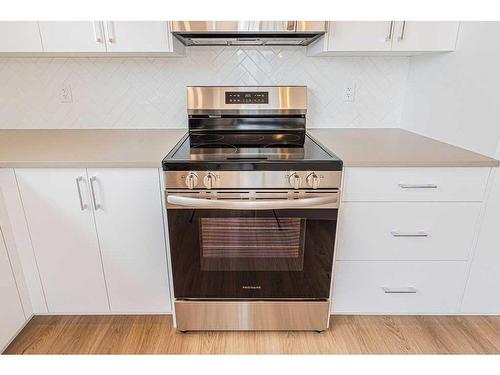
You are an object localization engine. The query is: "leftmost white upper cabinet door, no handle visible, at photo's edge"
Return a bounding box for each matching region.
[0,21,42,52]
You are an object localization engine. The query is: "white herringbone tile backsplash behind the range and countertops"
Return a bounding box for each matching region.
[0,47,409,129]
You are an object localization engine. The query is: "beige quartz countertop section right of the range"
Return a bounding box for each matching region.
[309,128,499,167]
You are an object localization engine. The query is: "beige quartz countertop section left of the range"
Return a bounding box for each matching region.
[0,129,186,168]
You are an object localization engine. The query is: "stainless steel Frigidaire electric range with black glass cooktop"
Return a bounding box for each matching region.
[163,86,342,331]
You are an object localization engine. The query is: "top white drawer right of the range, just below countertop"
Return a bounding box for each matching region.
[343,168,490,202]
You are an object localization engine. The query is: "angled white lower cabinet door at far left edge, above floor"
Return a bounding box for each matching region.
[0,223,25,353]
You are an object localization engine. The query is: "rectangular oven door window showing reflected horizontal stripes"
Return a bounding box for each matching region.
[199,216,306,271]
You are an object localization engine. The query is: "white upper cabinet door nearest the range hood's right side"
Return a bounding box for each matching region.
[327,21,393,52]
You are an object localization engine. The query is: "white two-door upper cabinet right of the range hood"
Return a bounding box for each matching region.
[308,21,460,56]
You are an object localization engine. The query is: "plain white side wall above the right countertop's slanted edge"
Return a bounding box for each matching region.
[401,22,500,156]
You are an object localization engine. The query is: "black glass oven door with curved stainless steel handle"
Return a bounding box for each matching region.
[167,191,338,299]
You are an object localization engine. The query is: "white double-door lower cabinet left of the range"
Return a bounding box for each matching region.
[16,168,170,313]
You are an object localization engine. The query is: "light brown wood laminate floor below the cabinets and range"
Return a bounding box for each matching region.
[5,315,500,354]
